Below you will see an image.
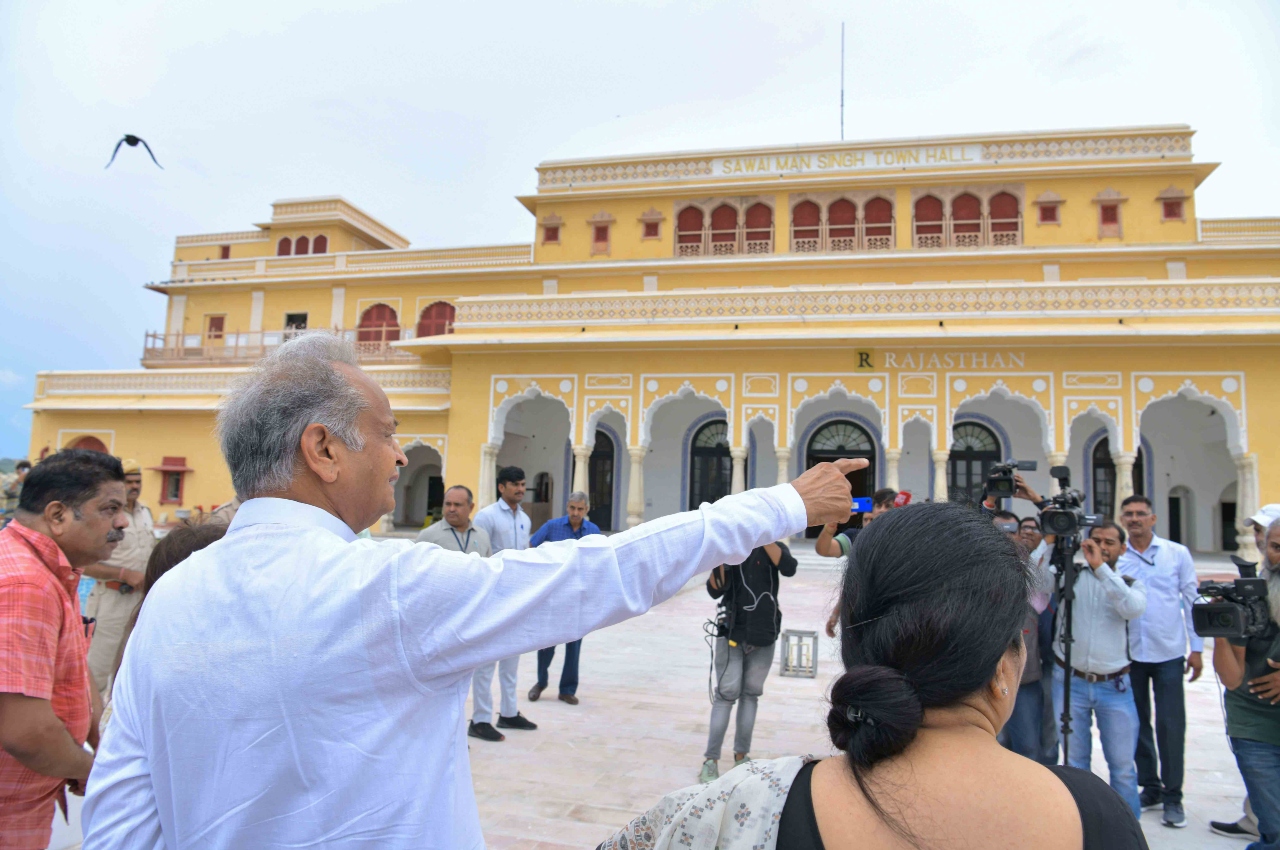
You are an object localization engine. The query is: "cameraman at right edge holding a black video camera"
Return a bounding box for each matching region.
[1193,520,1280,850]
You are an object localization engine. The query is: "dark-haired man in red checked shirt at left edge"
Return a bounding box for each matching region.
[0,449,129,850]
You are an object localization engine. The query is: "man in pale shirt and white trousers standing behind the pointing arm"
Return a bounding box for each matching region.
[467,466,538,741]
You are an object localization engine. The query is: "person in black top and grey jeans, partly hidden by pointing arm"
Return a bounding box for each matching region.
[698,543,796,782]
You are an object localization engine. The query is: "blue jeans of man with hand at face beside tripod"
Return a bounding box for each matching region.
[1053,664,1142,819]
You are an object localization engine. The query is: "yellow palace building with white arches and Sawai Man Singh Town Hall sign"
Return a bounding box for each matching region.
[31,125,1280,552]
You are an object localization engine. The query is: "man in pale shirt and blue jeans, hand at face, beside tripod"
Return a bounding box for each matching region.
[1053,521,1147,818]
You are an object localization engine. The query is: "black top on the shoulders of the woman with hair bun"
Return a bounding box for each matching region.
[778,762,1147,850]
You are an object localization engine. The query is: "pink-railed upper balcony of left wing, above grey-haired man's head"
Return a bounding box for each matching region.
[142,328,419,366]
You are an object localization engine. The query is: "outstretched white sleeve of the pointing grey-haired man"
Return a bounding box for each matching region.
[390,484,808,685]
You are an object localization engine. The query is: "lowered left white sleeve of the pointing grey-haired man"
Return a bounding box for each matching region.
[81,646,165,850]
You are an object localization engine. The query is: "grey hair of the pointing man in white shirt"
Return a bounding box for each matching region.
[218,333,365,499]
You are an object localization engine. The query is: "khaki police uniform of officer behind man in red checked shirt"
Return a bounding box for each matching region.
[84,502,156,699]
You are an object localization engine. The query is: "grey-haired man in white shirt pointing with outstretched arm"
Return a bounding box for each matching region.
[82,334,865,850]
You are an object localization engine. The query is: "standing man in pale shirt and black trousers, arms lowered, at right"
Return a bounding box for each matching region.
[1117,495,1204,828]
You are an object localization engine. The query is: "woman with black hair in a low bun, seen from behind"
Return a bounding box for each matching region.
[600,503,1147,850]
